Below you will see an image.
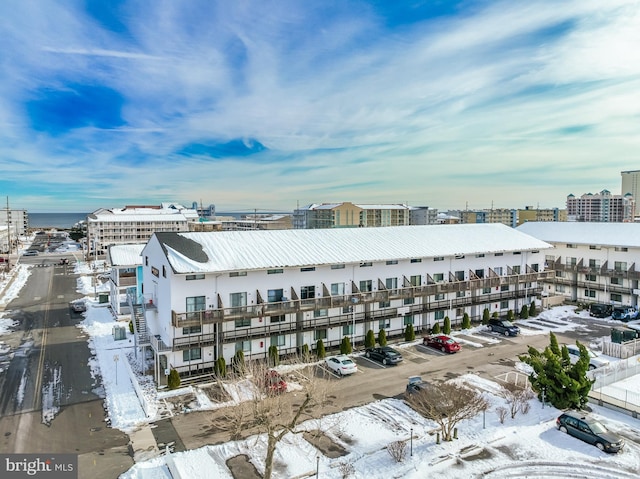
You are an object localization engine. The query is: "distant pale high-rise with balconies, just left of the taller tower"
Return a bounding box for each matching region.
[567,190,635,223]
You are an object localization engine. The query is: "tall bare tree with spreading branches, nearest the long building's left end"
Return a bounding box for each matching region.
[216,361,329,479]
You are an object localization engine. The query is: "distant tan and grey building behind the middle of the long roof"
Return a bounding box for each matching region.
[293,202,411,229]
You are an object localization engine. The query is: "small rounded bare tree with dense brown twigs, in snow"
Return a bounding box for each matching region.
[407,381,487,441]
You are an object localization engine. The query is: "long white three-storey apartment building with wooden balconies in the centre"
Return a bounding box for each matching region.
[139,224,553,385]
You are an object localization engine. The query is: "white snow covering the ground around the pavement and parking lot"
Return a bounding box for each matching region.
[0,263,640,479]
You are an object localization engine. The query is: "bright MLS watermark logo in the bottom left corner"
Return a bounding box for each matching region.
[0,454,78,479]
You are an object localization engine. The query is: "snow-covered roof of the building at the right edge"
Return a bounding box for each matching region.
[517,221,640,248]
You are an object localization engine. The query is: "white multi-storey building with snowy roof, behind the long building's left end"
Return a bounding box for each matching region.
[86,203,198,257]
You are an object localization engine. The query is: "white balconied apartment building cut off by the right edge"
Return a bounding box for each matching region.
[517,222,640,306]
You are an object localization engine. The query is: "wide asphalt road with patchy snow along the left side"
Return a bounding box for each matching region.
[0,253,133,479]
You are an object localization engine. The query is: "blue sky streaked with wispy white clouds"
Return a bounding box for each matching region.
[0,0,640,212]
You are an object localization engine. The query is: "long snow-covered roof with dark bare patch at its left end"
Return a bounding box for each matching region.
[155,223,552,273]
